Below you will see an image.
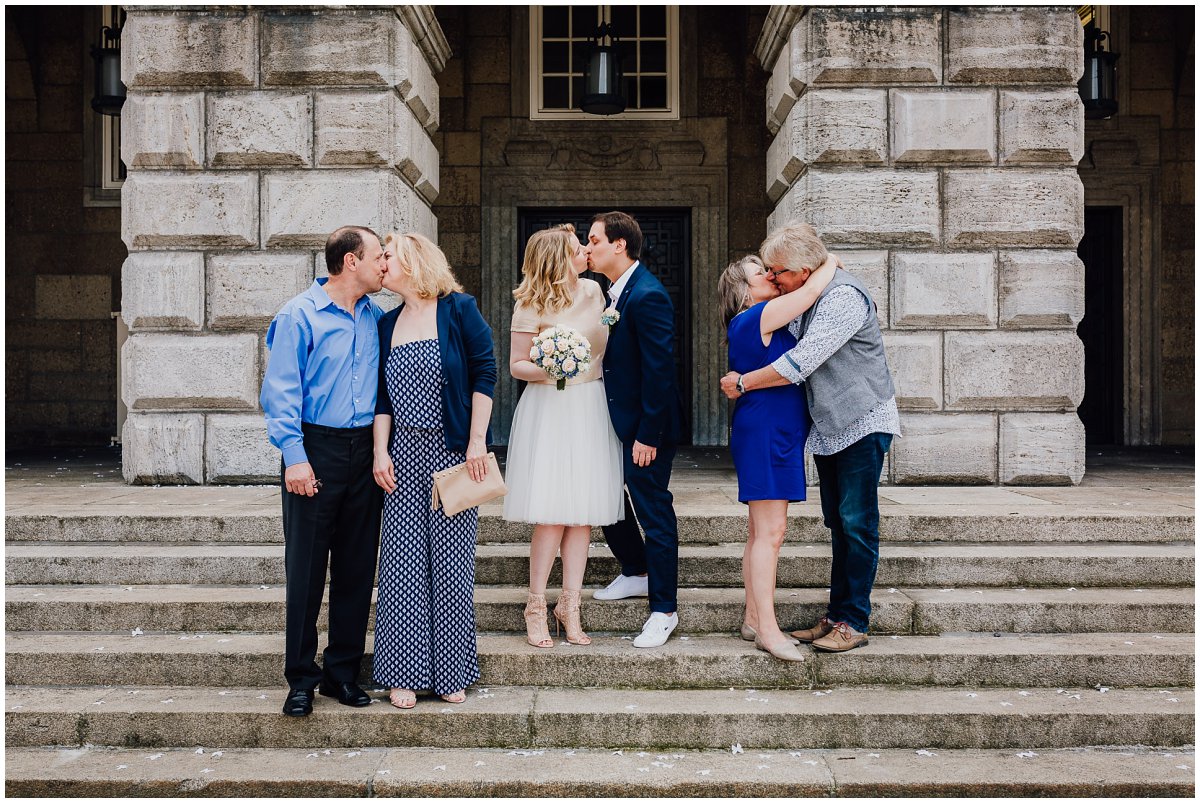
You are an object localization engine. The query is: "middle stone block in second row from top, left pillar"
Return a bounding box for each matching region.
[208,91,312,167]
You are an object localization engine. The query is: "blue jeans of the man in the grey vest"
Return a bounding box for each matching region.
[812,432,892,633]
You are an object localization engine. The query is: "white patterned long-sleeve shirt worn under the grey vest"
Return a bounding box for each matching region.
[772,286,900,455]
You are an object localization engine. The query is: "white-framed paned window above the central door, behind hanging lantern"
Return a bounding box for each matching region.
[529,6,679,120]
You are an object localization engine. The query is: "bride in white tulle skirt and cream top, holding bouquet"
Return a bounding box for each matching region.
[504,224,624,647]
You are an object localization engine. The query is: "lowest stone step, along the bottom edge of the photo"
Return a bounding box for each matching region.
[5,745,1195,798]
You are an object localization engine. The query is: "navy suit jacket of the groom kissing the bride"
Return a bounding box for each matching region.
[604,263,684,448]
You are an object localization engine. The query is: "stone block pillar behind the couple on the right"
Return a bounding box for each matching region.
[758,6,1085,484]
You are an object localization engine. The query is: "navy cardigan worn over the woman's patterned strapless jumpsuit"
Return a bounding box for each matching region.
[376,293,497,451]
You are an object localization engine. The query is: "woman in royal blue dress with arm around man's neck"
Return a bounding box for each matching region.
[718,252,838,661]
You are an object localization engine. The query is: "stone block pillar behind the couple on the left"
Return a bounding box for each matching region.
[121,6,449,483]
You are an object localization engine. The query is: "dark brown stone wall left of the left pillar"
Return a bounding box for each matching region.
[5,6,126,449]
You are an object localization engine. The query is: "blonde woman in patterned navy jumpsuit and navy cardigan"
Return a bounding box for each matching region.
[367,234,496,708]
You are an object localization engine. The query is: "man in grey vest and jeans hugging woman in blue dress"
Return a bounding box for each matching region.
[721,223,900,652]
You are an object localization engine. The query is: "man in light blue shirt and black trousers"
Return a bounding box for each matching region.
[259,226,388,717]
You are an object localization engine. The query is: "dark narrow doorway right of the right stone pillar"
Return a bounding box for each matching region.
[1079,206,1129,445]
